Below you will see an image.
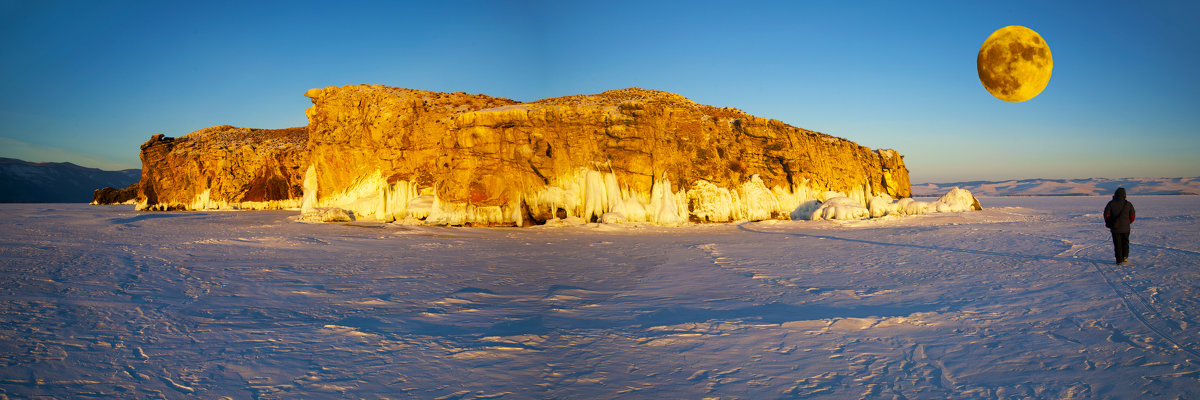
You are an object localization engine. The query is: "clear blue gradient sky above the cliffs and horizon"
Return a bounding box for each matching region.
[0,0,1200,183]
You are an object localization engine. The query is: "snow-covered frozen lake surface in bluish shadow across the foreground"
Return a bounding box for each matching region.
[0,196,1200,399]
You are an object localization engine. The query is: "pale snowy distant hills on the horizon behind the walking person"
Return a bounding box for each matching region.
[912,177,1200,196]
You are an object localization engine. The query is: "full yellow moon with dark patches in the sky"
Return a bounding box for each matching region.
[976,25,1054,103]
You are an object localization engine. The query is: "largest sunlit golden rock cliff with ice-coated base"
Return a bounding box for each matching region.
[300,85,911,226]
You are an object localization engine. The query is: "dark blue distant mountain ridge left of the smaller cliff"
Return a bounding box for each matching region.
[0,157,142,203]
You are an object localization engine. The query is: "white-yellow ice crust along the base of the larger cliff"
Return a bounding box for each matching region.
[301,166,973,222]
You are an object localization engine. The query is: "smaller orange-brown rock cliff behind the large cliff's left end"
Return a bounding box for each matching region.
[138,125,307,210]
